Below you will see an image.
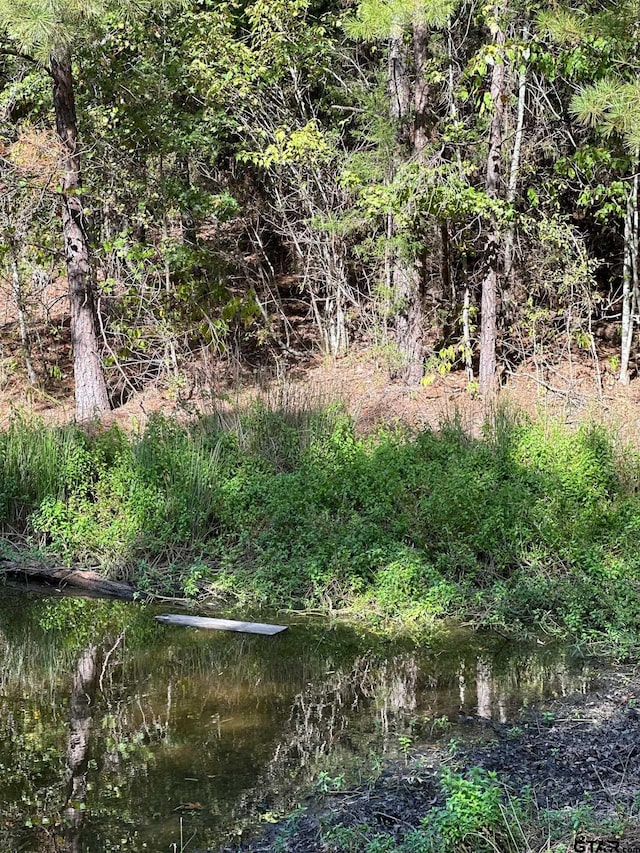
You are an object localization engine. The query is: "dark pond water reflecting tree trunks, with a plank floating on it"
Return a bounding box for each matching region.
[0,587,597,853]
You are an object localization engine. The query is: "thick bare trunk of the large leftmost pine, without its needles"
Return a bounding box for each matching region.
[51,50,109,421]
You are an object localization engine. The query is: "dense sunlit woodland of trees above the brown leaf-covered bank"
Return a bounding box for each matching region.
[0,0,640,420]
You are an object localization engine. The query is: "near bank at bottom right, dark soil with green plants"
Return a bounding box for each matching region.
[222,672,640,853]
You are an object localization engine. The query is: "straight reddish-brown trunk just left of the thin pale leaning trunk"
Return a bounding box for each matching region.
[478,6,505,396]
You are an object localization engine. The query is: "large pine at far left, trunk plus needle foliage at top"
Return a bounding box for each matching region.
[0,0,124,421]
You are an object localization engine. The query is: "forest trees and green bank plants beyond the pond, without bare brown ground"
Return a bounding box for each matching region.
[0,0,640,654]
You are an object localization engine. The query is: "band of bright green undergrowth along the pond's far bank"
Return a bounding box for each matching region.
[0,404,640,650]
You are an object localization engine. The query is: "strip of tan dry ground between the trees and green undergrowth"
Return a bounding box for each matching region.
[6,327,640,442]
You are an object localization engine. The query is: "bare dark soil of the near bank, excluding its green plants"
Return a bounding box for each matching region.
[220,671,640,853]
